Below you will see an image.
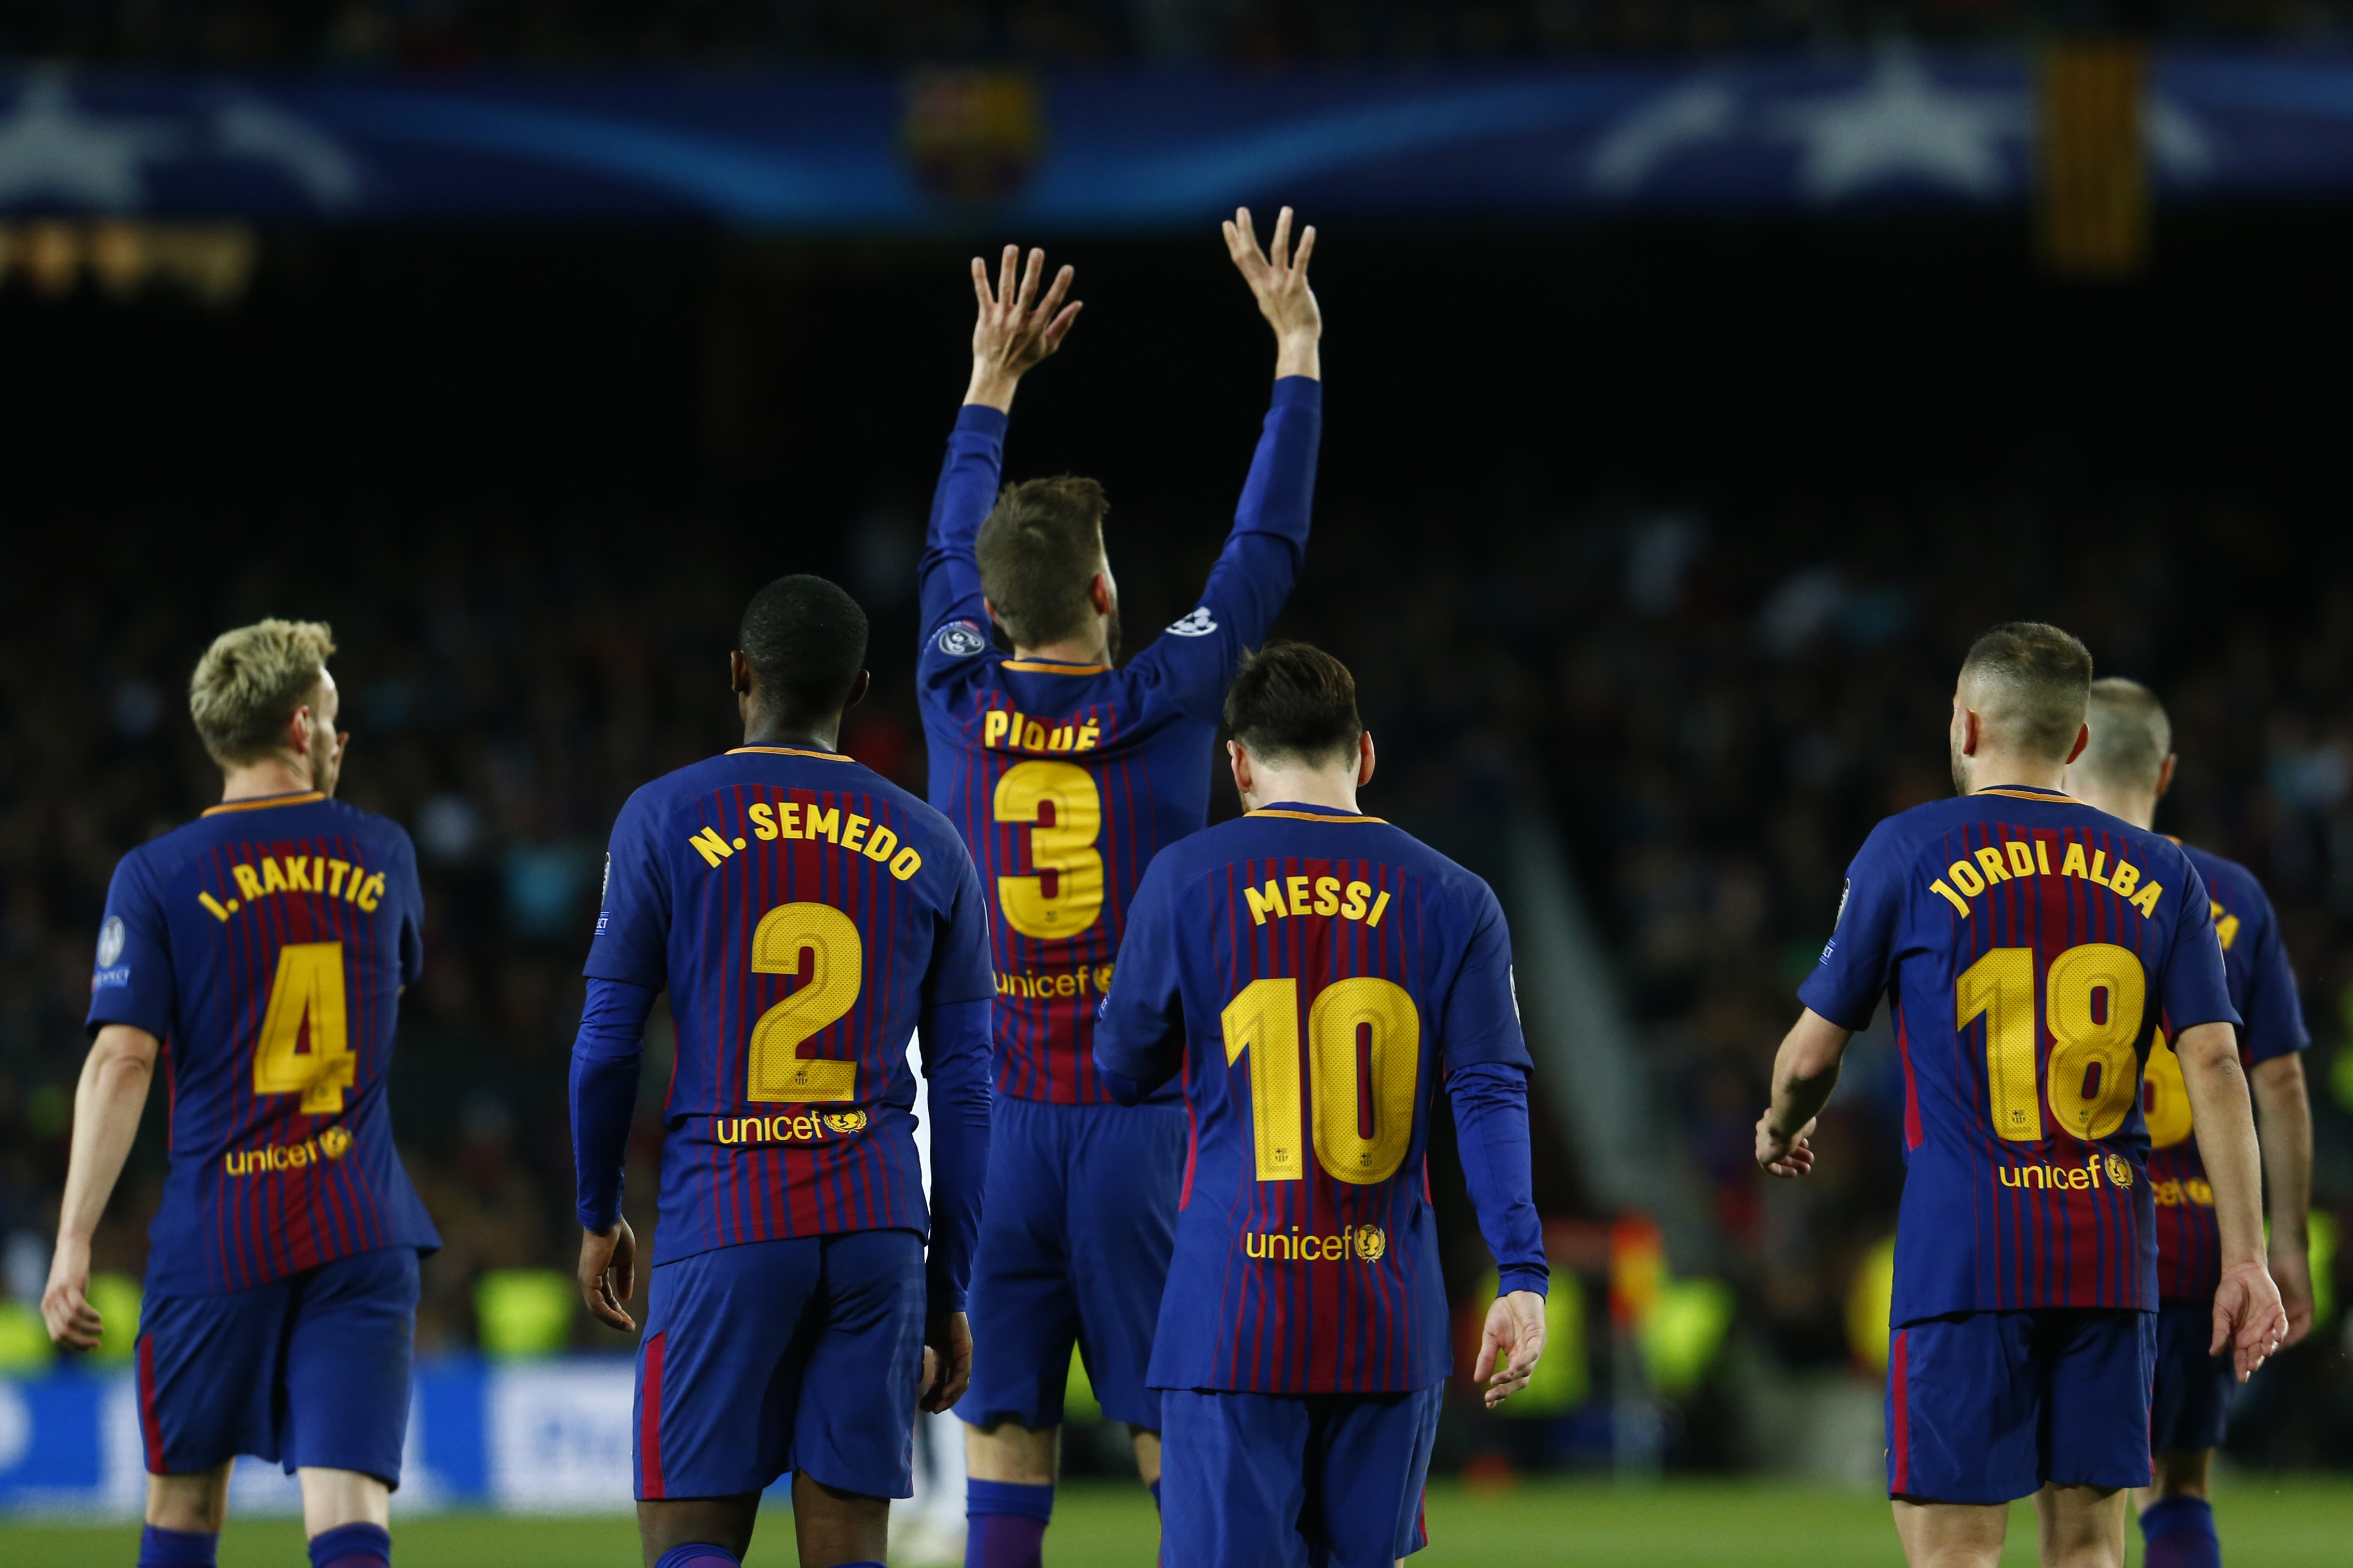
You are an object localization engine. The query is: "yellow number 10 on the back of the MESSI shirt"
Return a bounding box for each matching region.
[1219,975,1421,1186]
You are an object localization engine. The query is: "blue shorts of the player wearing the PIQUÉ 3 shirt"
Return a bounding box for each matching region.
[955,1095,1186,1431]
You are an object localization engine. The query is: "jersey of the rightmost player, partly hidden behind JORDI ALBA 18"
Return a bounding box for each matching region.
[2141,845,2313,1302]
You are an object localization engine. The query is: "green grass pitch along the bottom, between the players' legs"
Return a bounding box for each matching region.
[0,1476,2353,1568]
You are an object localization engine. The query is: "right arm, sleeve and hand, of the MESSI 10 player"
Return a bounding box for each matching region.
[1438,888,1551,1410]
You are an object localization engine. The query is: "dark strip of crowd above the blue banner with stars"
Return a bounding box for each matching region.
[0,0,2348,71]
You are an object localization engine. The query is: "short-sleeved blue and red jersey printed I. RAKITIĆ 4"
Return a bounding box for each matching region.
[89,793,440,1295]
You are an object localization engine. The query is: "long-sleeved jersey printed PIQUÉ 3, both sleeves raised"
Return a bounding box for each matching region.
[917,377,1322,1104]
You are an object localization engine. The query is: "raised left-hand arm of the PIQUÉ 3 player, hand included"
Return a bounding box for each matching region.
[917,245,1080,652]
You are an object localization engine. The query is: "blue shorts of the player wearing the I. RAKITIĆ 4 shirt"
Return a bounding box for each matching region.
[139,1248,416,1488]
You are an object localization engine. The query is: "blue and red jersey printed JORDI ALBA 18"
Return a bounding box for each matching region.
[1797,787,2238,1326]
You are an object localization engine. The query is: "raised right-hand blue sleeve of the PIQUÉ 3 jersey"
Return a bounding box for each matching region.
[1139,377,1322,721]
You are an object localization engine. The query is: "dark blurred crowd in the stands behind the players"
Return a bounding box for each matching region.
[0,490,2353,1450]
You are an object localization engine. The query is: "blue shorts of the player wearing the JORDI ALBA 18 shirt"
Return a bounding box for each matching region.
[1887,1307,2158,1502]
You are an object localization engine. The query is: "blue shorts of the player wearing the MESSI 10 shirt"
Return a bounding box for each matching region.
[1160,1387,1445,1568]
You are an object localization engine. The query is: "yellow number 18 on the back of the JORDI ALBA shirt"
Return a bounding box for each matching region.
[1953,942,2148,1142]
